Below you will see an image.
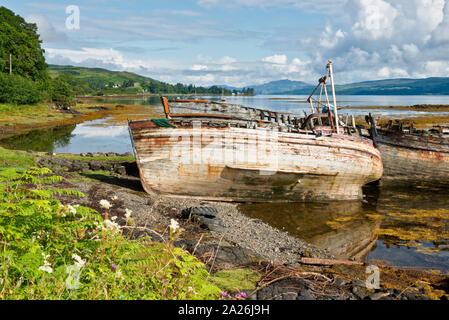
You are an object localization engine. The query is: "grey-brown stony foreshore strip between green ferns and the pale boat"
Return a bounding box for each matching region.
[28,153,449,300]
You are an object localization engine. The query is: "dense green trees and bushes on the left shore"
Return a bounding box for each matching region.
[0,6,74,105]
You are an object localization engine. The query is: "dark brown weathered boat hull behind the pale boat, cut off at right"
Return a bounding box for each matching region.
[366,114,449,184]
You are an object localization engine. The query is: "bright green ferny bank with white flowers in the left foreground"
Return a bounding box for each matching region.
[0,148,257,300]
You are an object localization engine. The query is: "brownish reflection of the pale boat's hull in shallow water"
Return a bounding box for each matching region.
[240,201,381,260]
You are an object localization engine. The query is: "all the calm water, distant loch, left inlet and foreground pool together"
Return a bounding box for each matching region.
[0,96,449,272]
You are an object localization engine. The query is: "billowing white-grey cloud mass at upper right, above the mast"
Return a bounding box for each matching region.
[265,0,449,83]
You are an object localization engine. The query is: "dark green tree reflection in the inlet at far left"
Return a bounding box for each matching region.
[0,125,76,152]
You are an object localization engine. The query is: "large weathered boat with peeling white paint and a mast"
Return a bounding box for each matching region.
[129,60,383,202]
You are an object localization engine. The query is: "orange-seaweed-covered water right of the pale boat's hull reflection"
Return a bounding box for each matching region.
[367,186,449,272]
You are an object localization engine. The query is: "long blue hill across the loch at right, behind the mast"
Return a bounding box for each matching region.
[272,77,449,95]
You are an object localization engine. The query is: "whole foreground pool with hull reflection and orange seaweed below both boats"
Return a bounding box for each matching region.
[240,186,449,272]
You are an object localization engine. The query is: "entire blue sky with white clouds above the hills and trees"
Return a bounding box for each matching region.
[4,0,449,87]
